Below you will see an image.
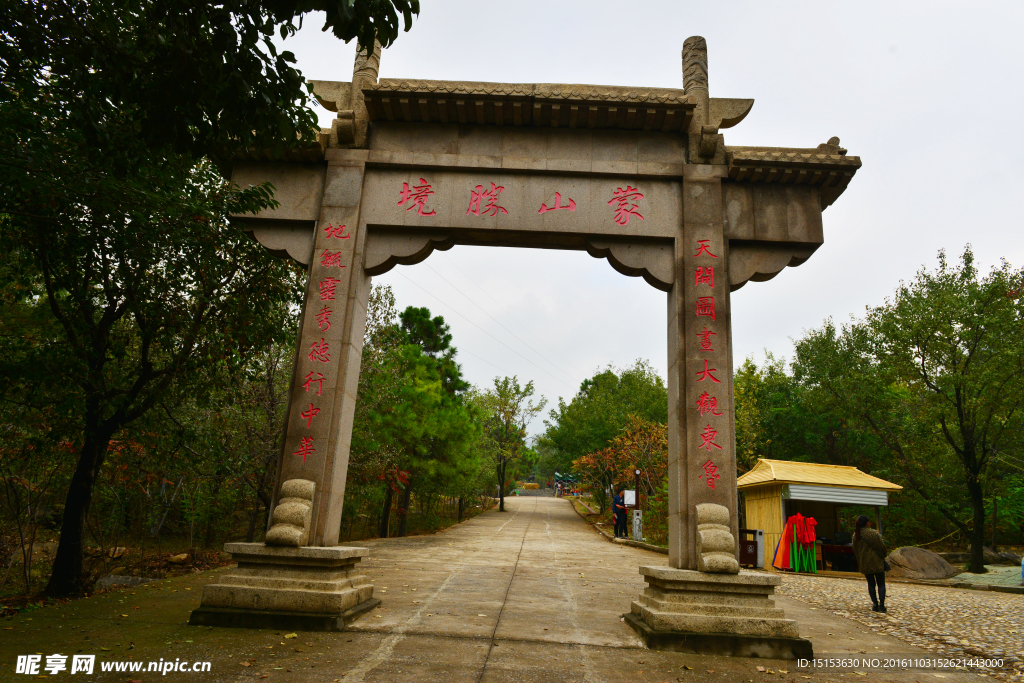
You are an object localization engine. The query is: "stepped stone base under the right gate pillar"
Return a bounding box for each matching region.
[625,566,813,659]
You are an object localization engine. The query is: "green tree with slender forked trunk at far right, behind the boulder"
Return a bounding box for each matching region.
[795,248,1024,572]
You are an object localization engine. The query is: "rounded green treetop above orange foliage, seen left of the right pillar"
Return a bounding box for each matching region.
[541,360,669,479]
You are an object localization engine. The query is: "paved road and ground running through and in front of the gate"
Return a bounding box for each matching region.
[0,497,987,683]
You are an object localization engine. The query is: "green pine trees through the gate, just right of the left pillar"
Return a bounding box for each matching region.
[345,286,483,537]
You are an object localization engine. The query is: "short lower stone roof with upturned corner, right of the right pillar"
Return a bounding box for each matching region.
[725,143,861,209]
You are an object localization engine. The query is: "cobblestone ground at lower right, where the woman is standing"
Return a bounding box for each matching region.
[778,575,1024,681]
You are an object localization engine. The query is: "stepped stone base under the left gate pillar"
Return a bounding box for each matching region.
[188,543,380,631]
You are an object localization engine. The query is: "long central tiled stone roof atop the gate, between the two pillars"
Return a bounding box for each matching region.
[362,79,695,131]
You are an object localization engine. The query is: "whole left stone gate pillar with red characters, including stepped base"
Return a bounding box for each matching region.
[189,49,380,631]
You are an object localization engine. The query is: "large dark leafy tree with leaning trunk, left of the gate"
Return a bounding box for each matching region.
[0,0,419,595]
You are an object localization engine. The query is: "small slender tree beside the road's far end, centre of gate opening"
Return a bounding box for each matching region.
[477,377,548,512]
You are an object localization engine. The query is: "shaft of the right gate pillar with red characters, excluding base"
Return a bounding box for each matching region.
[669,164,738,569]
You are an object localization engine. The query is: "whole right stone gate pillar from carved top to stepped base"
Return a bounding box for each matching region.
[624,37,813,658]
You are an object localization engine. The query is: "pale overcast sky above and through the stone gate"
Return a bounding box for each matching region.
[284,0,1024,433]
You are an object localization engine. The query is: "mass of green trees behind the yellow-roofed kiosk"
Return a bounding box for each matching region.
[735,249,1024,570]
